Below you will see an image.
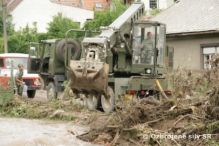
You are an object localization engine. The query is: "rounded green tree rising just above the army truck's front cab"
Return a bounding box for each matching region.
[48,13,80,38]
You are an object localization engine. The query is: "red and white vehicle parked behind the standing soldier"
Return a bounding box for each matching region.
[0,53,41,98]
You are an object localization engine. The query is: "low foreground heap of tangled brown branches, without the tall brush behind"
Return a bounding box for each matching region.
[79,95,219,145]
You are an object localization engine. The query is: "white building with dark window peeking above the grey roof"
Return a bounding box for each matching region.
[141,0,175,10]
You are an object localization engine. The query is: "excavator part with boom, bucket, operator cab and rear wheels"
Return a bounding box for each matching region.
[70,3,172,113]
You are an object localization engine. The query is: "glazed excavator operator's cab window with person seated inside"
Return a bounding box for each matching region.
[133,24,164,65]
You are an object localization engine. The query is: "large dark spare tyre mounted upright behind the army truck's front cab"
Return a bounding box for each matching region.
[56,39,81,63]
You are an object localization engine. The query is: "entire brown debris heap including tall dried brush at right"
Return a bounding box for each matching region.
[78,56,219,146]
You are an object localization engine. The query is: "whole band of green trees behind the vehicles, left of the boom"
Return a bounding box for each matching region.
[0,0,126,53]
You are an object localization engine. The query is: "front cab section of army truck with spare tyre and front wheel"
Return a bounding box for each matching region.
[28,39,81,100]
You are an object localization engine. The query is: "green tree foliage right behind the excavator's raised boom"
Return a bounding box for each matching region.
[84,0,126,30]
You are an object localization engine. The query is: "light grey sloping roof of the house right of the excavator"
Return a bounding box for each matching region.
[152,0,219,34]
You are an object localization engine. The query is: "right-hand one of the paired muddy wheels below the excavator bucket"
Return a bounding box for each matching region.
[101,87,115,114]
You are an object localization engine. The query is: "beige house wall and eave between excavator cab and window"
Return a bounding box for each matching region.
[167,35,219,70]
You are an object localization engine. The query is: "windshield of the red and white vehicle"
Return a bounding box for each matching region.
[5,57,28,69]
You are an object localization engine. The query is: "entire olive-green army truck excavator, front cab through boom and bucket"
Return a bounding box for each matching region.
[27,3,172,113]
